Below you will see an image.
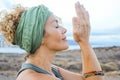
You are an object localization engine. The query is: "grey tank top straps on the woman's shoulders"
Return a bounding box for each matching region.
[17,63,63,80]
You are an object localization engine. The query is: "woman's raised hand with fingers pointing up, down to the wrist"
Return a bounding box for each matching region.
[72,2,90,43]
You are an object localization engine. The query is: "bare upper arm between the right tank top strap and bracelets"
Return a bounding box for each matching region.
[56,67,85,80]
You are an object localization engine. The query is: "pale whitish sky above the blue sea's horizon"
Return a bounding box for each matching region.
[0,0,120,35]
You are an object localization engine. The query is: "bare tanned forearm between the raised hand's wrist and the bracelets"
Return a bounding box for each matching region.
[79,42,102,73]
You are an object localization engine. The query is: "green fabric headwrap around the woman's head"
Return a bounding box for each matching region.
[14,5,52,53]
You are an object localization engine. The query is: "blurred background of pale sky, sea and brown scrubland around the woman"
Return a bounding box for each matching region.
[0,0,120,80]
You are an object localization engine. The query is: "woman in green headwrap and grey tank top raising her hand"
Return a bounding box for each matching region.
[2,2,104,80]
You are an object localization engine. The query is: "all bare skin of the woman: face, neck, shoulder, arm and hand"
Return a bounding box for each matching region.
[17,2,103,80]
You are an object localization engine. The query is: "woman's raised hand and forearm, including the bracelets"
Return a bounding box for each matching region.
[72,2,104,80]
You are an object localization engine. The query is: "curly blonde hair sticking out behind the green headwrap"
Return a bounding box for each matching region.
[0,5,25,43]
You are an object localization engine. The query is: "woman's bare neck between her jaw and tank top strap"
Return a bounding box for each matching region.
[26,46,56,74]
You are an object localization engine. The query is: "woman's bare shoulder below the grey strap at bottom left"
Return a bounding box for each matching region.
[16,69,56,80]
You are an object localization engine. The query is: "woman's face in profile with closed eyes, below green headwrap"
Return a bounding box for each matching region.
[43,15,68,51]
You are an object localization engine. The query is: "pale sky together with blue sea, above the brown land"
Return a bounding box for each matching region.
[0,0,120,51]
